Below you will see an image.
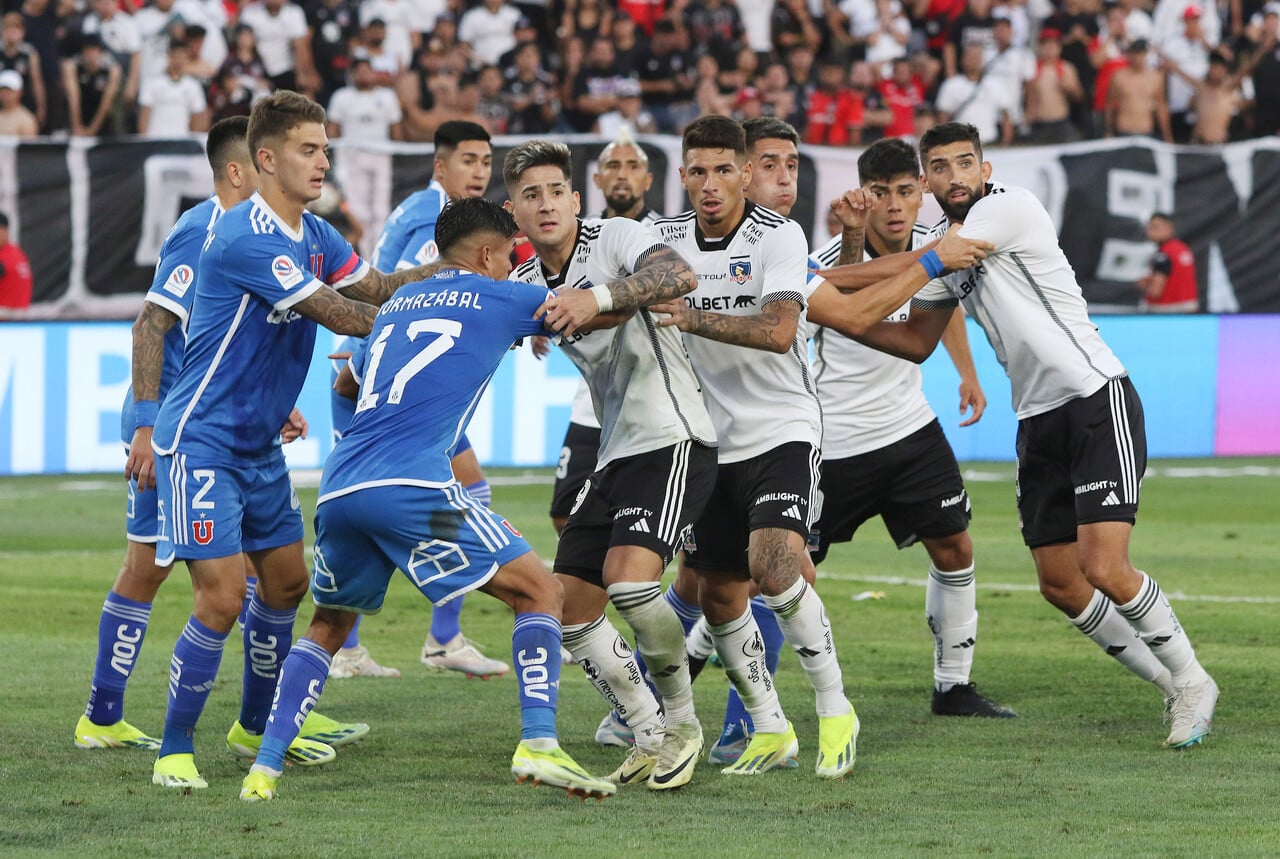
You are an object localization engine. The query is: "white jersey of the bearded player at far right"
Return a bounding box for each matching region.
[913,182,1126,420]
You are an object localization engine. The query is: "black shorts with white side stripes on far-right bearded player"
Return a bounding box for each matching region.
[1018,378,1147,548]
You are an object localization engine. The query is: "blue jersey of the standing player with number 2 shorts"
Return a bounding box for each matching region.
[152,193,369,462]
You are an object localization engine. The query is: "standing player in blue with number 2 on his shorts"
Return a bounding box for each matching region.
[151,91,450,789]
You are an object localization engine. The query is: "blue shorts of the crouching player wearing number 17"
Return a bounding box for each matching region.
[311,483,532,614]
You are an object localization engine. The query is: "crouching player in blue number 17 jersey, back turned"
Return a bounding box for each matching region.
[241,198,614,801]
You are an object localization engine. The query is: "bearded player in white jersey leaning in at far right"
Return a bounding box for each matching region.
[823,123,1217,749]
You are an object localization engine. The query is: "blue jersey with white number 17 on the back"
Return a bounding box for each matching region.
[320,270,550,501]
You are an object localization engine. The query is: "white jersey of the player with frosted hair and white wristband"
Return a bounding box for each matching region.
[512,218,716,469]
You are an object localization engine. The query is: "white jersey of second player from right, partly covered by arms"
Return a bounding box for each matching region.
[810,224,936,460]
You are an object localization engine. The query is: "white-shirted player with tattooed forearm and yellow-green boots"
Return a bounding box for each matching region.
[653,115,859,778]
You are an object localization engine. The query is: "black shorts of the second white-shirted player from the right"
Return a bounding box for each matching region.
[809,419,970,563]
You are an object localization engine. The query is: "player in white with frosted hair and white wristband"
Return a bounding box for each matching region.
[503,141,716,790]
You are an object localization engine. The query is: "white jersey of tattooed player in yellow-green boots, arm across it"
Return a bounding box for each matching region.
[654,202,822,463]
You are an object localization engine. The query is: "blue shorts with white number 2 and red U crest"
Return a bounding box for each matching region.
[156,448,303,565]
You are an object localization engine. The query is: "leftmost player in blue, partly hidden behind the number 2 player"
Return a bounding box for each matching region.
[74,116,277,750]
